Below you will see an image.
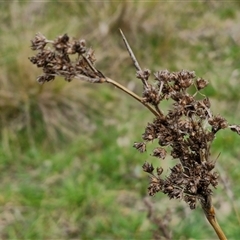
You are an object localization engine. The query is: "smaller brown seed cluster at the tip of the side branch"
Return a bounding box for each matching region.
[29,33,104,83]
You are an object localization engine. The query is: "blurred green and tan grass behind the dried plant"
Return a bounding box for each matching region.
[0,1,240,239]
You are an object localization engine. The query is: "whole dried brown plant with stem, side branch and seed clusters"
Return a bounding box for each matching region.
[30,30,240,239]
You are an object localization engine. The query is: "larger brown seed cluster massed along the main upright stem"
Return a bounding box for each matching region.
[134,70,237,209]
